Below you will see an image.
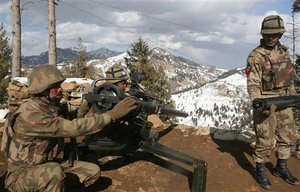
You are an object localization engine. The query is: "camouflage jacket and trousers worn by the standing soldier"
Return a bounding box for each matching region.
[246,42,296,163]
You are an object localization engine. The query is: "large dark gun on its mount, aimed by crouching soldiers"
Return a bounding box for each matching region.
[79,76,207,192]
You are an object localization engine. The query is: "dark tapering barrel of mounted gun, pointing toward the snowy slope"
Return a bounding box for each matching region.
[136,100,188,117]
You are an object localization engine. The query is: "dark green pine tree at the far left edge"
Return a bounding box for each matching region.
[0,23,11,104]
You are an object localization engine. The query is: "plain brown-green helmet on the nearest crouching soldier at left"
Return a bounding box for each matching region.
[28,65,65,94]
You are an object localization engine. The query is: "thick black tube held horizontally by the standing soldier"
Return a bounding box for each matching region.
[252,96,300,112]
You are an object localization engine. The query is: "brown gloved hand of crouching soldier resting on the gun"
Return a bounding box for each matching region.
[106,97,137,120]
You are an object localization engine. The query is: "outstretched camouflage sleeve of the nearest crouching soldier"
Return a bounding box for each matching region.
[18,109,111,137]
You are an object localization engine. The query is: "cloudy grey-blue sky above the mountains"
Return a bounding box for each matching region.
[0,0,299,69]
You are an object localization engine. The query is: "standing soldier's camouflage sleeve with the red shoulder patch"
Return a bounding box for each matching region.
[246,54,262,101]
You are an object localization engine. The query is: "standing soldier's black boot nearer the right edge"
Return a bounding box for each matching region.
[273,159,299,185]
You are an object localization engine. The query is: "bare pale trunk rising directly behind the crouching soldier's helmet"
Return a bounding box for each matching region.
[48,0,57,66]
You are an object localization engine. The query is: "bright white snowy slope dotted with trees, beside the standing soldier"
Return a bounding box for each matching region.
[172,74,248,128]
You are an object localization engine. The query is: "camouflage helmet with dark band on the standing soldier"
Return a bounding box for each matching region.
[260,15,285,35]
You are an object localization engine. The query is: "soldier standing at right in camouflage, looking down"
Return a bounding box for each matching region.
[245,15,299,189]
